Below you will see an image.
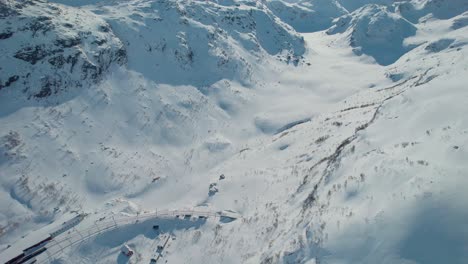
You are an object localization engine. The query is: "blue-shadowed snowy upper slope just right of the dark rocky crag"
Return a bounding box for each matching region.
[52,0,305,86]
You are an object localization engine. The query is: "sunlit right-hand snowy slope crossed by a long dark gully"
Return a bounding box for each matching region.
[154,12,468,264]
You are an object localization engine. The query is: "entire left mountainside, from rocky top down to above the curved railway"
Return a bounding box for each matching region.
[0,1,305,245]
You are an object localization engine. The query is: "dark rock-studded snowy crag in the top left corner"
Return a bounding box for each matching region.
[0,0,126,99]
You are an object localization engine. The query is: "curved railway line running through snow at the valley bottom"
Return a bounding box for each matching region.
[0,210,239,264]
